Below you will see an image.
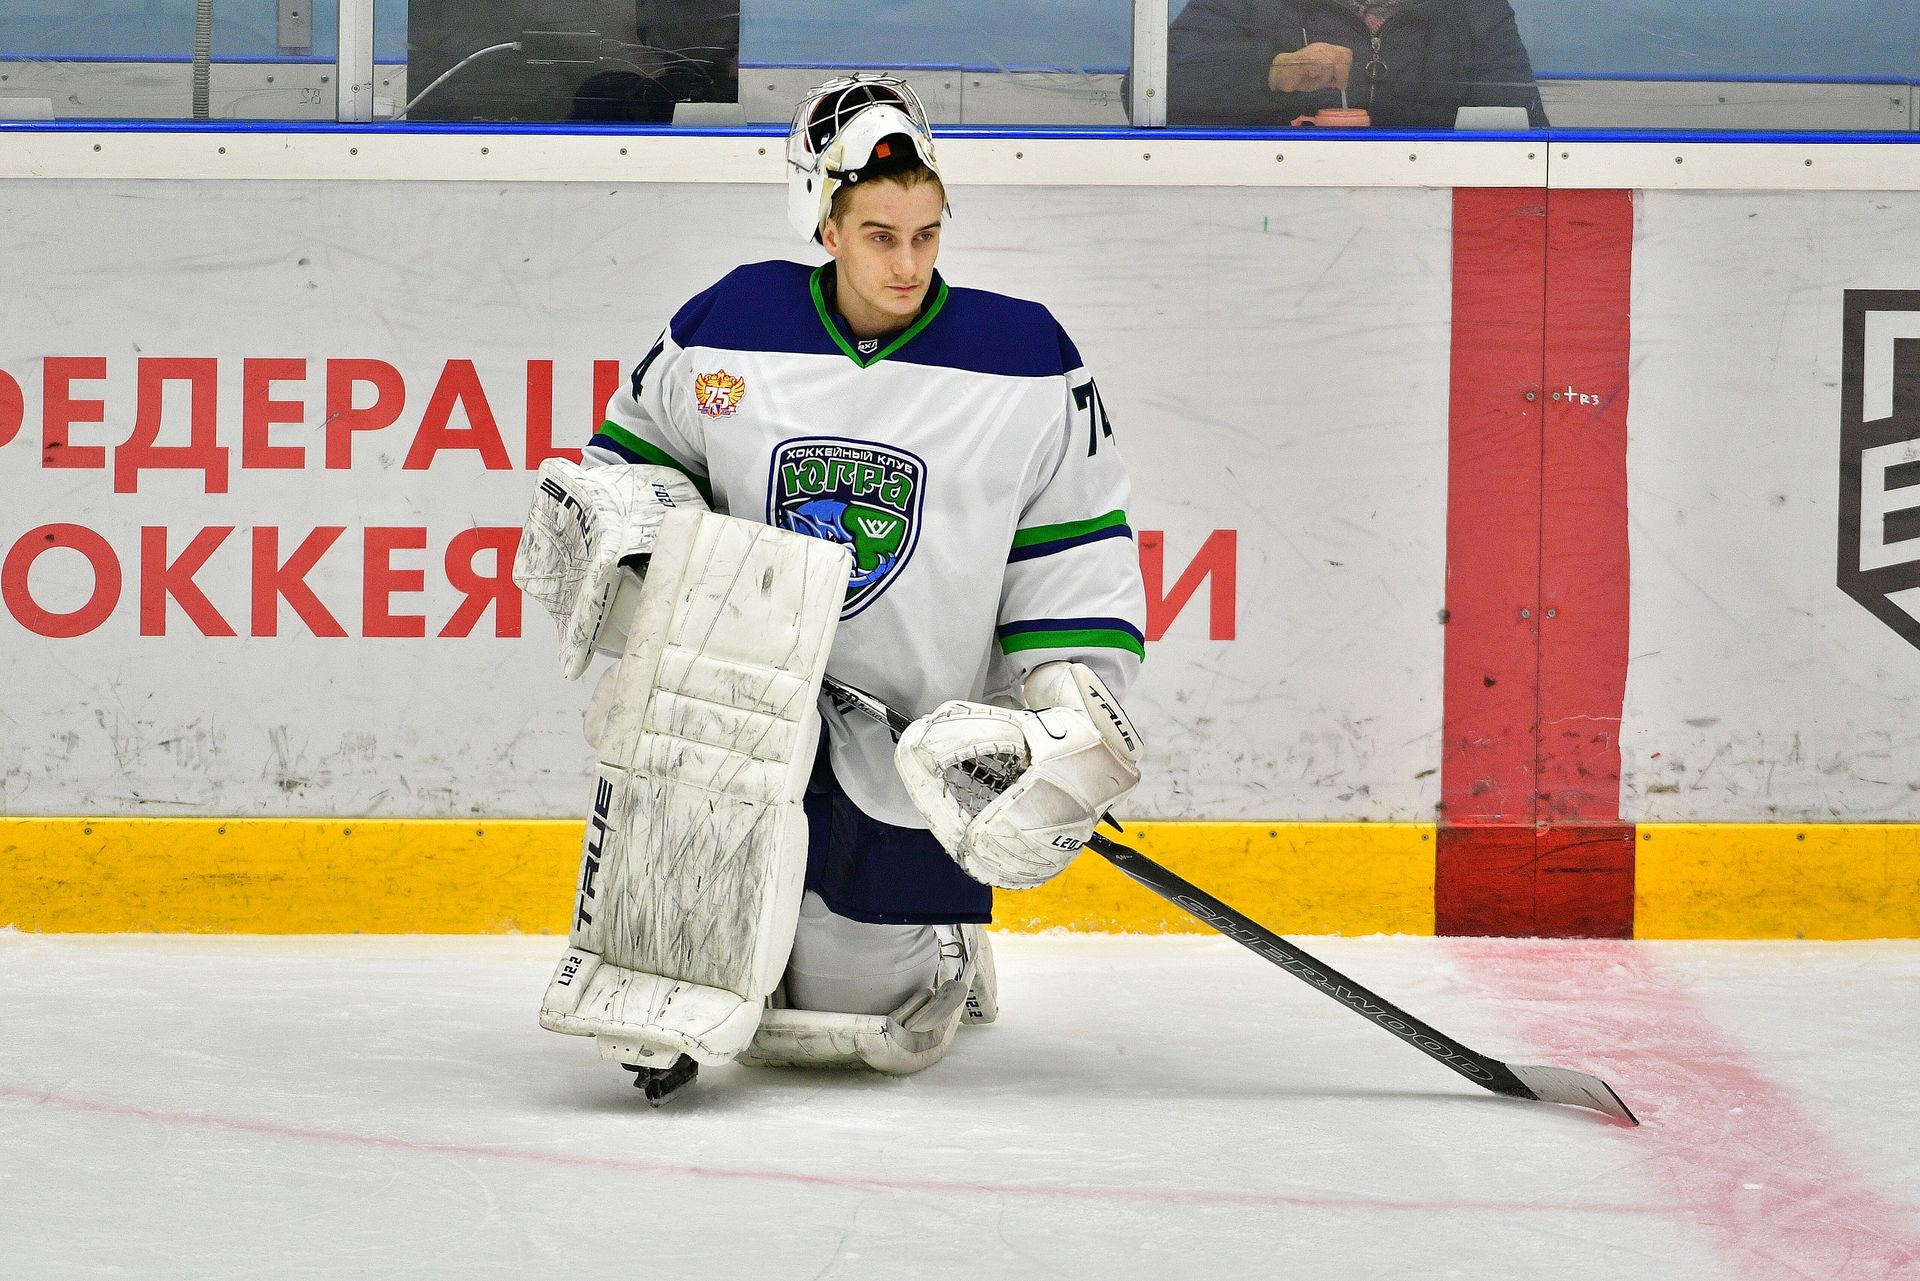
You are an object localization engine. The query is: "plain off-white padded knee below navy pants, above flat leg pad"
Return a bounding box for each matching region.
[781,891,941,1014]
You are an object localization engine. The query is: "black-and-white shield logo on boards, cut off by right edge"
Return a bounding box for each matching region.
[1839,290,1920,649]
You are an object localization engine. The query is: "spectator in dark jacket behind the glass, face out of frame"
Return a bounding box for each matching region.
[1167,0,1548,129]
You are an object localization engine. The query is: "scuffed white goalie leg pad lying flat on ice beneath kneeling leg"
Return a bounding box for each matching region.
[739,910,996,1076]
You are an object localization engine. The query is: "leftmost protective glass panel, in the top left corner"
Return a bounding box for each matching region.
[0,0,340,121]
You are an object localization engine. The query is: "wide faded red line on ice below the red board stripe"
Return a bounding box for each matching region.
[1455,939,1920,1281]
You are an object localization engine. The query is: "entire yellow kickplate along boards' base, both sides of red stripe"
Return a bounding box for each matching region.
[11,818,1920,939]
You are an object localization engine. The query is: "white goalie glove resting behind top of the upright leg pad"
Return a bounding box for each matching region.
[513,459,707,680]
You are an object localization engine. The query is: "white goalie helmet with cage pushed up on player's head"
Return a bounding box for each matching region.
[787,71,941,240]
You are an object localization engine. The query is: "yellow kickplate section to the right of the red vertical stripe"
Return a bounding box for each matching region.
[1634,824,1920,939]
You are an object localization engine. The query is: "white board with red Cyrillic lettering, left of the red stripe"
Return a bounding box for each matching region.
[0,179,1450,818]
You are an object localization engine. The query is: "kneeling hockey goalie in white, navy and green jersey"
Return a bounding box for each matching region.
[515,75,1144,1102]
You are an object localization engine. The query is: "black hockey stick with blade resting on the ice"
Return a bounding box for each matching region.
[826,676,1640,1125]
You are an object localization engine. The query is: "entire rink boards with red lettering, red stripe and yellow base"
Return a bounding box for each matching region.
[0,134,1920,937]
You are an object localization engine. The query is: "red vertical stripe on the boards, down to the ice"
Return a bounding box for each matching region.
[1434,188,1634,937]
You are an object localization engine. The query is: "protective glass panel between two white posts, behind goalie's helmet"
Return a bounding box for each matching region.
[395,0,1133,127]
